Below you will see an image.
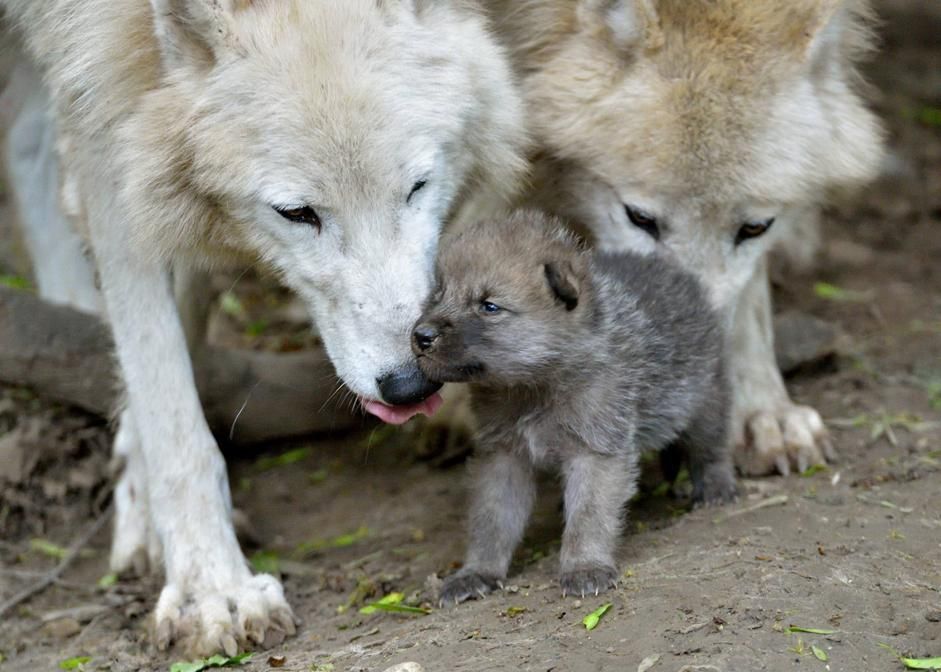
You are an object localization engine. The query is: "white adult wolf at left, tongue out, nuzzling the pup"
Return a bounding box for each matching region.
[0,0,525,654]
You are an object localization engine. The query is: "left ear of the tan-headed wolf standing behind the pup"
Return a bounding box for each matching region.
[578,0,663,52]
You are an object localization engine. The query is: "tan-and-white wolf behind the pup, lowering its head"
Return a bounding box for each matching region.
[489,0,882,473]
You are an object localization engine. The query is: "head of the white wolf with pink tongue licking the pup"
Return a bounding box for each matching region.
[125,0,525,418]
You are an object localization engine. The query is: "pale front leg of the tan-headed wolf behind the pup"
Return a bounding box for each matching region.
[730,260,836,475]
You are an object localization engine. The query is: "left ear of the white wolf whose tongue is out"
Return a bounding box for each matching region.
[150,0,241,71]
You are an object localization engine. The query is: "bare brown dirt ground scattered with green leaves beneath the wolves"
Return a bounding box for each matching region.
[0,2,941,672]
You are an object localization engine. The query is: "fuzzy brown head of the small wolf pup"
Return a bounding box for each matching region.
[412,211,590,385]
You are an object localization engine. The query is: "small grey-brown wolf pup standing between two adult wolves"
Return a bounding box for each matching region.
[412,210,736,604]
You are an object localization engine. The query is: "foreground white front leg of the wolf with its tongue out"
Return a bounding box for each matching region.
[89,217,294,655]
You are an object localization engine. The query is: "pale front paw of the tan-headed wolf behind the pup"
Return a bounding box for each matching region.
[735,403,837,476]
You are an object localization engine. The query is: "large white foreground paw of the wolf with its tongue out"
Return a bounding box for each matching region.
[154,570,296,657]
